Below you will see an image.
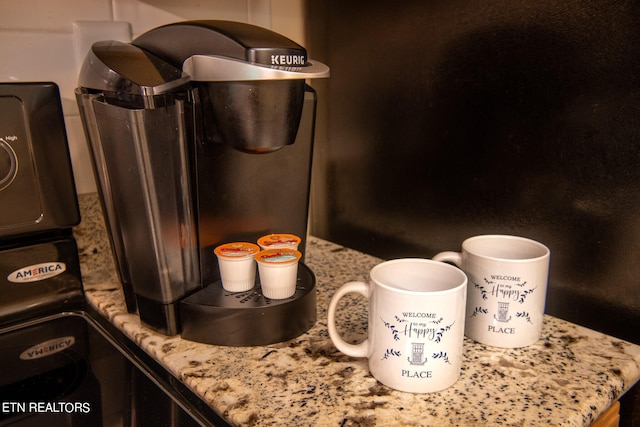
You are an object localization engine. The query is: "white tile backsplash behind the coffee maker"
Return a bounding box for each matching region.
[0,0,304,194]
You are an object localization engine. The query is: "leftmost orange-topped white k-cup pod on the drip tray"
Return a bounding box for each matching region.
[214,242,260,292]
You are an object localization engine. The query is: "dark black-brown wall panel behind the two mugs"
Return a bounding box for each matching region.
[308,0,640,350]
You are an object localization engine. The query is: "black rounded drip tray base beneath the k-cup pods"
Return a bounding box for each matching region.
[180,263,317,346]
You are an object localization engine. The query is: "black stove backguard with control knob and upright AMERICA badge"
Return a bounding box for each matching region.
[0,83,83,327]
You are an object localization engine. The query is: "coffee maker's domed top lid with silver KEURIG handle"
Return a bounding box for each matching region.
[131,20,329,82]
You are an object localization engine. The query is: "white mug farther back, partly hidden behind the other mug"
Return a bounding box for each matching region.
[433,235,550,348]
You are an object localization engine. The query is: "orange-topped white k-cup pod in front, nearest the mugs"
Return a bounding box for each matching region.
[255,248,302,299]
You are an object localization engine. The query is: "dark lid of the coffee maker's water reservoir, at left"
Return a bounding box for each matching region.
[78,41,190,96]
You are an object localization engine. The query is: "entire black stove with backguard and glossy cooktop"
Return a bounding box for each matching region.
[0,83,226,426]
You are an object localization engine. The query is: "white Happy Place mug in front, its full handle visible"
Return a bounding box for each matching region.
[328,259,467,393]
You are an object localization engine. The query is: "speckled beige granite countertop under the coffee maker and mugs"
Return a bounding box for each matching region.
[74,195,640,426]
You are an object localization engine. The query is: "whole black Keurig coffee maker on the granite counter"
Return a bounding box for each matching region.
[76,21,329,345]
